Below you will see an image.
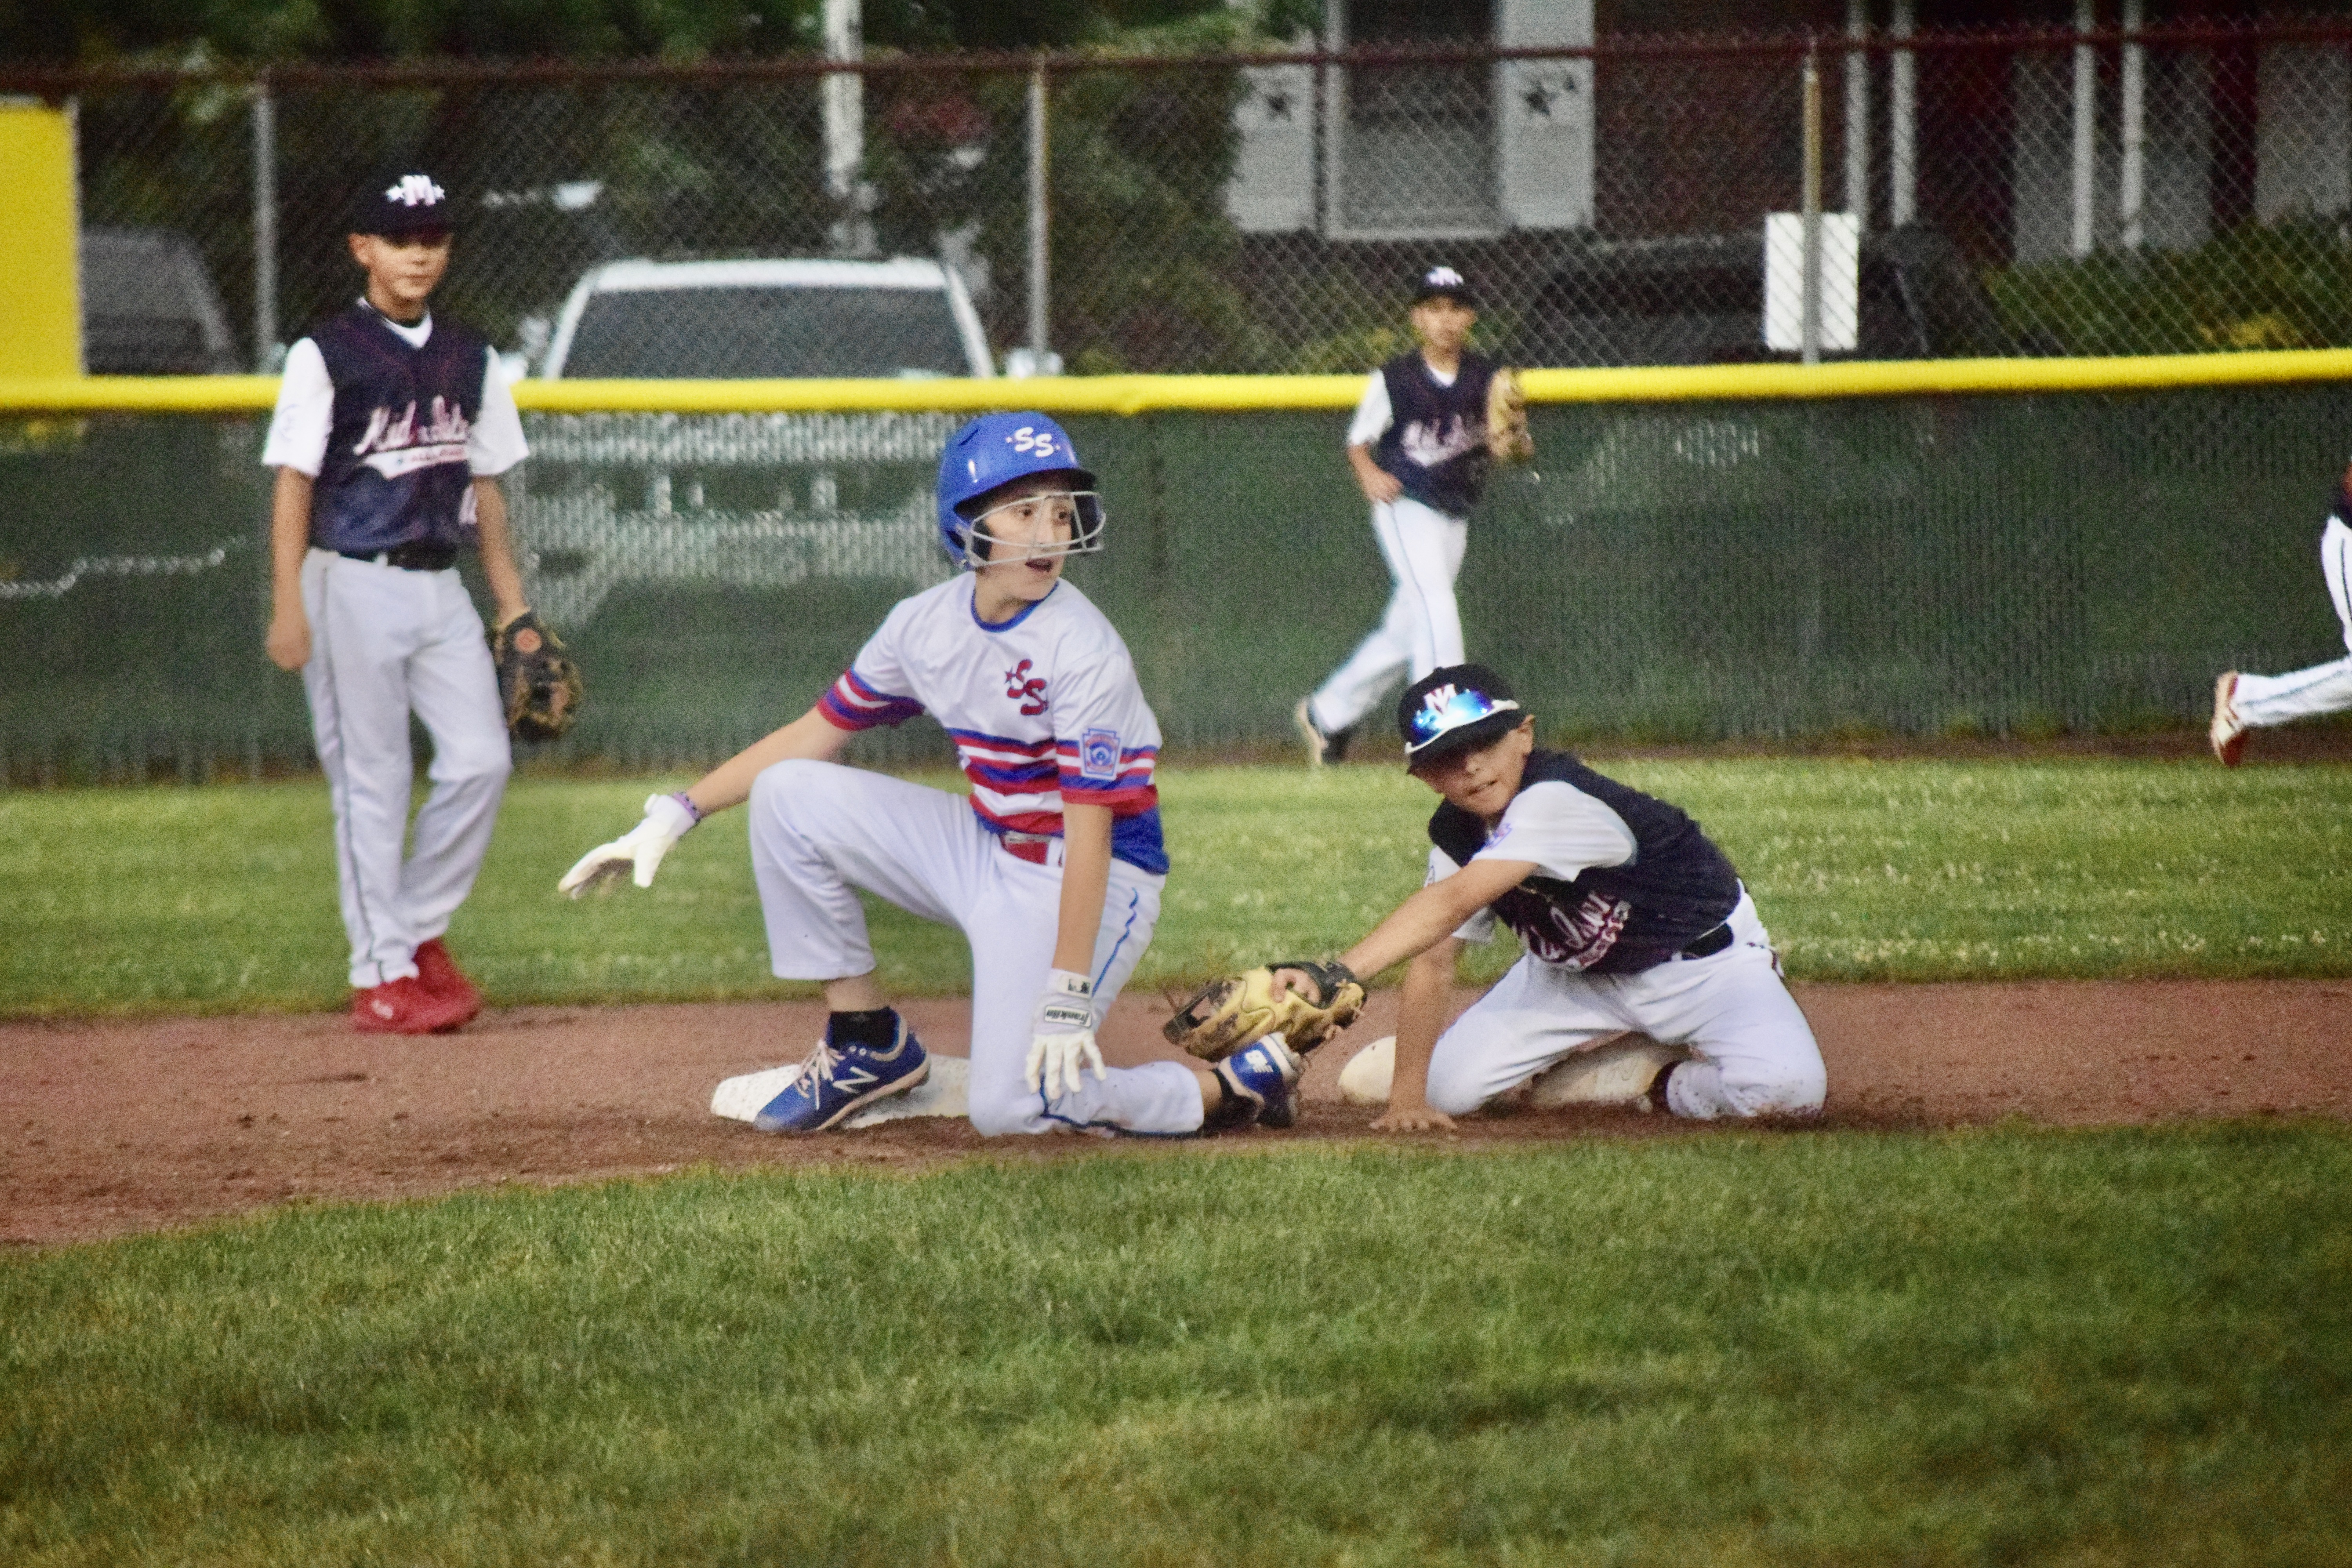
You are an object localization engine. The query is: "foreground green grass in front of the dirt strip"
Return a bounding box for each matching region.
[0,1126,2352,1568]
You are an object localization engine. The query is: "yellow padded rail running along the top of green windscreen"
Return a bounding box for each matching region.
[0,348,2352,414]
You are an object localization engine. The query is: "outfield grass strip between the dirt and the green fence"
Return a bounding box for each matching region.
[0,759,2352,1016]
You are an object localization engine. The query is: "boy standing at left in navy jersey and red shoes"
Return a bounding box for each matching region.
[261,174,529,1034]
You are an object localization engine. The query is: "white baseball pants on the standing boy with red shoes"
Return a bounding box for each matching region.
[301,550,515,990]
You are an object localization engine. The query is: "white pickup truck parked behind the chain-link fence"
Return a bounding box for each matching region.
[517,259,995,628]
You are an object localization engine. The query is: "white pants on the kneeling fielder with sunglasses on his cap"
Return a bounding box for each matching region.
[1428,893,1830,1119]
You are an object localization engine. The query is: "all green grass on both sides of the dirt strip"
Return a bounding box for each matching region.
[0,759,2352,1568]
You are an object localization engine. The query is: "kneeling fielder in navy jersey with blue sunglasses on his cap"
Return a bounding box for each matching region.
[1287,665,1828,1131]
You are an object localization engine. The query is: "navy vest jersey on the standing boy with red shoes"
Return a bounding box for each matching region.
[310,303,489,552]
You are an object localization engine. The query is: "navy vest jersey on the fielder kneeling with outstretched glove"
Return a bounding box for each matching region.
[1430,748,1740,976]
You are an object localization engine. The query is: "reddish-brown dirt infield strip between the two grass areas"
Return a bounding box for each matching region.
[0,980,2352,1246]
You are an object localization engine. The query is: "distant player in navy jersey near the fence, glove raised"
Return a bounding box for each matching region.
[1291,266,1496,766]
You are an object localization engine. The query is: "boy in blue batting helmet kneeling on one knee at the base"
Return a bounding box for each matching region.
[560,414,1298,1136]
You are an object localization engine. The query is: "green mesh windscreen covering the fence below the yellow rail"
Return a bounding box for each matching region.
[0,386,2352,783]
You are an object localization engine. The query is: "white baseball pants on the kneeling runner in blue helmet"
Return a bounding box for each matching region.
[750,759,1202,1136]
